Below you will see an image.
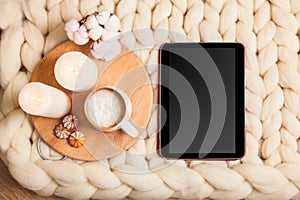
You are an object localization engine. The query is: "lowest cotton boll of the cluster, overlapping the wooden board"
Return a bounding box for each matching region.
[91,39,121,61]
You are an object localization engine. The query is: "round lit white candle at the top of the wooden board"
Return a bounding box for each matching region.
[54,51,98,92]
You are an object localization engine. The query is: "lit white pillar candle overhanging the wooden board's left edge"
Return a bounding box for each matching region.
[19,82,71,118]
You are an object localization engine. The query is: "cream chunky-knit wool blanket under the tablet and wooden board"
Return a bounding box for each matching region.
[0,0,300,199]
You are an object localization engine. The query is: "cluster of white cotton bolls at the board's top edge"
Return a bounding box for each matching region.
[65,10,121,61]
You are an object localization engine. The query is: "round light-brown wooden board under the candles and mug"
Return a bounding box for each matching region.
[31,41,153,161]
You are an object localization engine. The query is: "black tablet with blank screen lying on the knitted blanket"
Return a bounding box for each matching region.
[158,43,245,159]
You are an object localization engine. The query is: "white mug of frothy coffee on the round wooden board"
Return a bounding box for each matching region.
[84,86,139,137]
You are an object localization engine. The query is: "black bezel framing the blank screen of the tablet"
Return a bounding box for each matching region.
[158,43,245,160]
